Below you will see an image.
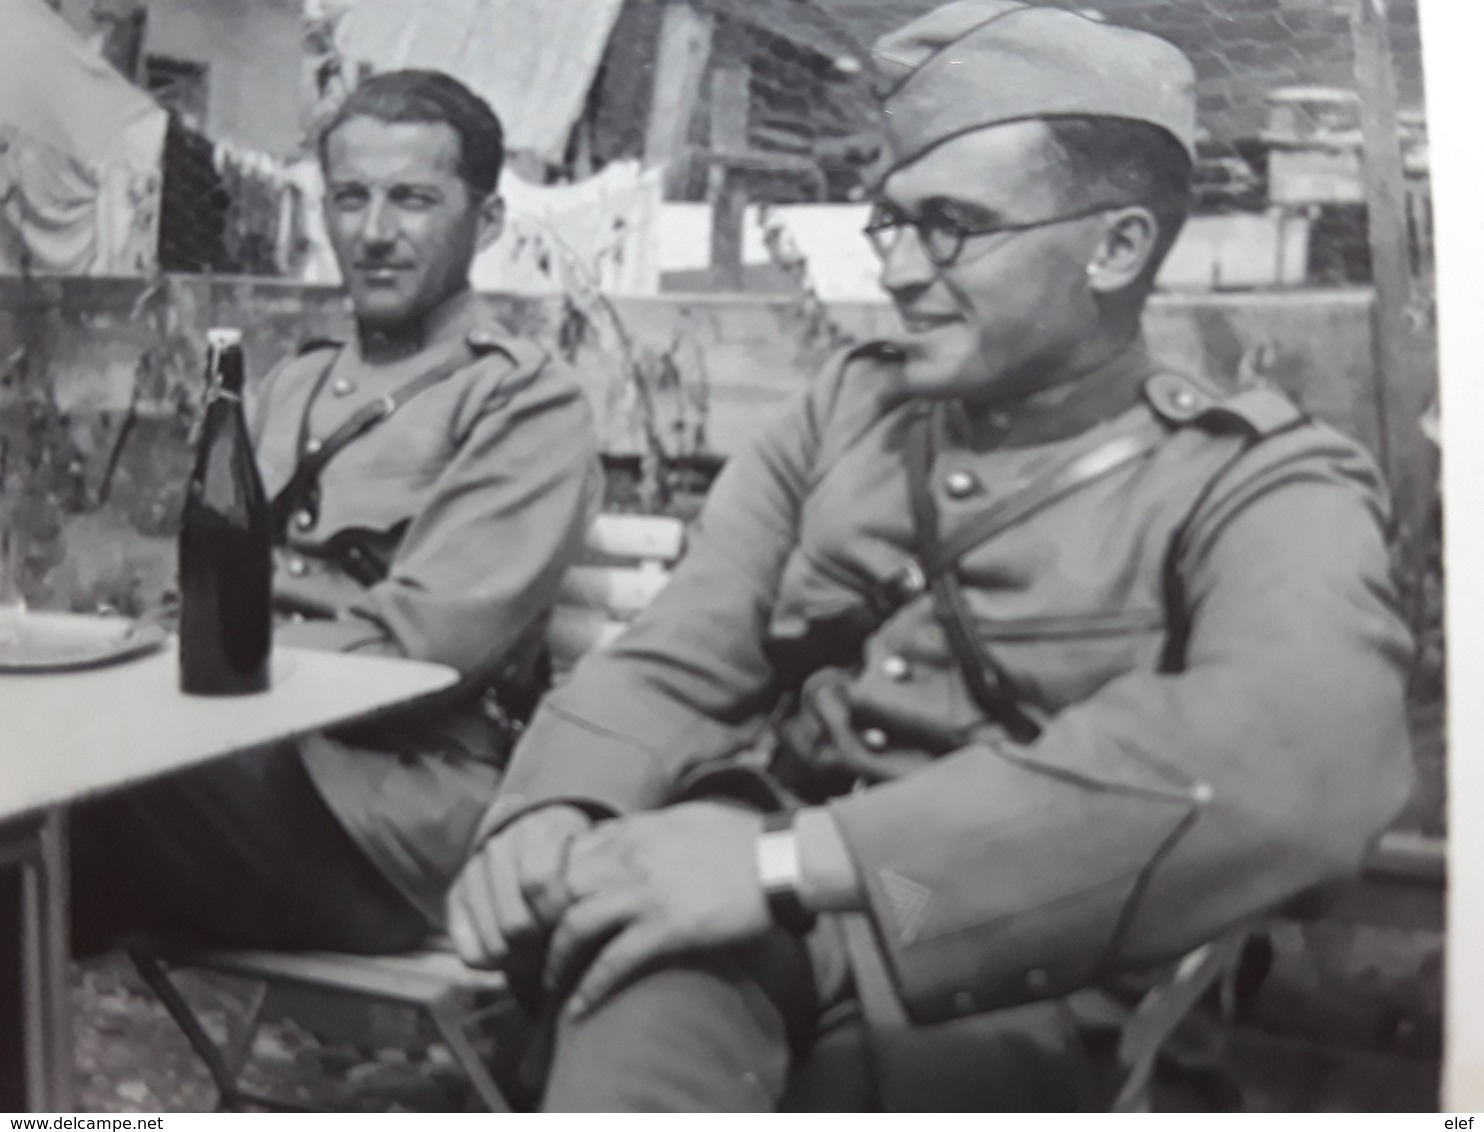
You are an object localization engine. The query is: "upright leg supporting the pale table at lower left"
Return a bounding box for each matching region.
[21,807,73,1113]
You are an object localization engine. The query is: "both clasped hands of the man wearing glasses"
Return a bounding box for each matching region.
[448,803,772,1015]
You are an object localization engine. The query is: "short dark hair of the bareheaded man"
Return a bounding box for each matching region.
[319,70,505,197]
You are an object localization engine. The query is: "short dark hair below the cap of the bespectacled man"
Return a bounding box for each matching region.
[1046,114,1192,282]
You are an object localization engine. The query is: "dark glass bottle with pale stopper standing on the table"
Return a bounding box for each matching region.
[180,329,273,696]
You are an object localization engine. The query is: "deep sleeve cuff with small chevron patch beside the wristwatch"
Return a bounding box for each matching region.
[830,751,1195,1022]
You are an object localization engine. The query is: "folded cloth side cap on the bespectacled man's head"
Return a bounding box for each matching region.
[873,0,1196,180]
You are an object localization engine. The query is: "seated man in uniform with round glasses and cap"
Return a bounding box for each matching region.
[450,0,1410,1110]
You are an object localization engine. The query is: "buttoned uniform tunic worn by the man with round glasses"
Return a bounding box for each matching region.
[484,346,1410,1021]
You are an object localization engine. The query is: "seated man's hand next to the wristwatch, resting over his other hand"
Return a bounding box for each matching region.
[546,803,772,1013]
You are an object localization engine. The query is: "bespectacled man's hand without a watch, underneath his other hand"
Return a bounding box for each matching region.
[448,806,592,967]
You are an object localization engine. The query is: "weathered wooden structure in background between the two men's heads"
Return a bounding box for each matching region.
[568,0,876,289]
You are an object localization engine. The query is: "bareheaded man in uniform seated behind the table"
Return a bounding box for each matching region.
[4,71,601,1008]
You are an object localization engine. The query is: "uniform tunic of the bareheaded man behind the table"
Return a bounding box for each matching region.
[251,292,601,923]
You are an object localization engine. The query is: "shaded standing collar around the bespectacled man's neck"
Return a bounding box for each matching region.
[945,338,1160,448]
